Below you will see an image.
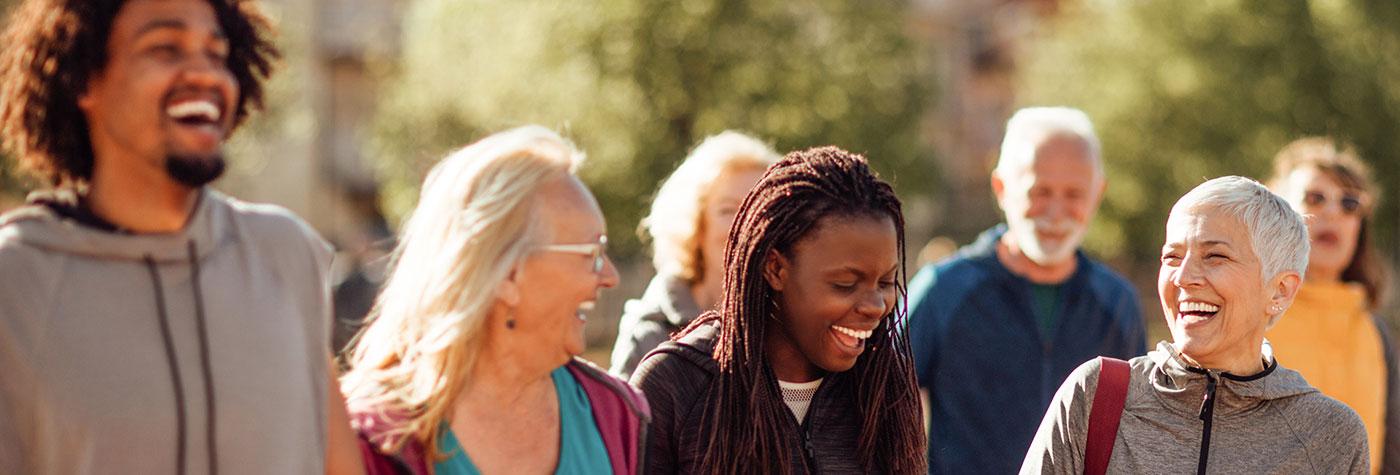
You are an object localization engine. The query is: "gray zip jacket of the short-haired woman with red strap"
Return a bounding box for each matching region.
[1021,342,1369,475]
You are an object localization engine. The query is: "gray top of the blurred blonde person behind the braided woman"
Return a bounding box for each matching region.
[609,275,700,380]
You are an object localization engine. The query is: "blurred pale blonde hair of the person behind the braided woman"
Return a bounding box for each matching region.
[641,130,783,282]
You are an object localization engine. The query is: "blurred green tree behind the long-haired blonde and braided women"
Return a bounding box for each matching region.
[372,0,934,256]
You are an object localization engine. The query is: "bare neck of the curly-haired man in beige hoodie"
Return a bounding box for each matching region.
[87,154,199,234]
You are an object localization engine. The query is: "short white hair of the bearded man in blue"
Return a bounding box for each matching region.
[994,106,1103,179]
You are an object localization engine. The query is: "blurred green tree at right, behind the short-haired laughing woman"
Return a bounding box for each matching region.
[1021,0,1400,276]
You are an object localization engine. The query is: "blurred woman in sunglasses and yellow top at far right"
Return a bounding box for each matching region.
[1267,137,1400,474]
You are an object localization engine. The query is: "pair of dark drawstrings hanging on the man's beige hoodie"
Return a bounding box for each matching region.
[144,241,218,475]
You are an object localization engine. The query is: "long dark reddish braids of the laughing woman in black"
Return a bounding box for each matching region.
[685,147,927,474]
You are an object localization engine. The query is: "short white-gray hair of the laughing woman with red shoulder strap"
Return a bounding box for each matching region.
[1172,177,1309,279]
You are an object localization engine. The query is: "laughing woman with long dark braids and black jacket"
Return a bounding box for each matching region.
[631,147,927,474]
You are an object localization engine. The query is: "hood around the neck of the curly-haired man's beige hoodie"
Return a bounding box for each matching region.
[0,188,234,263]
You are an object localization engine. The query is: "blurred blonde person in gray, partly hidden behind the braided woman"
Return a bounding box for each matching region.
[612,130,781,377]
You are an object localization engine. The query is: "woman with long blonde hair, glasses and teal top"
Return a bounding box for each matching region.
[340,126,648,475]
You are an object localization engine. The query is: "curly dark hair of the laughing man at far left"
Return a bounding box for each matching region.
[0,0,281,186]
